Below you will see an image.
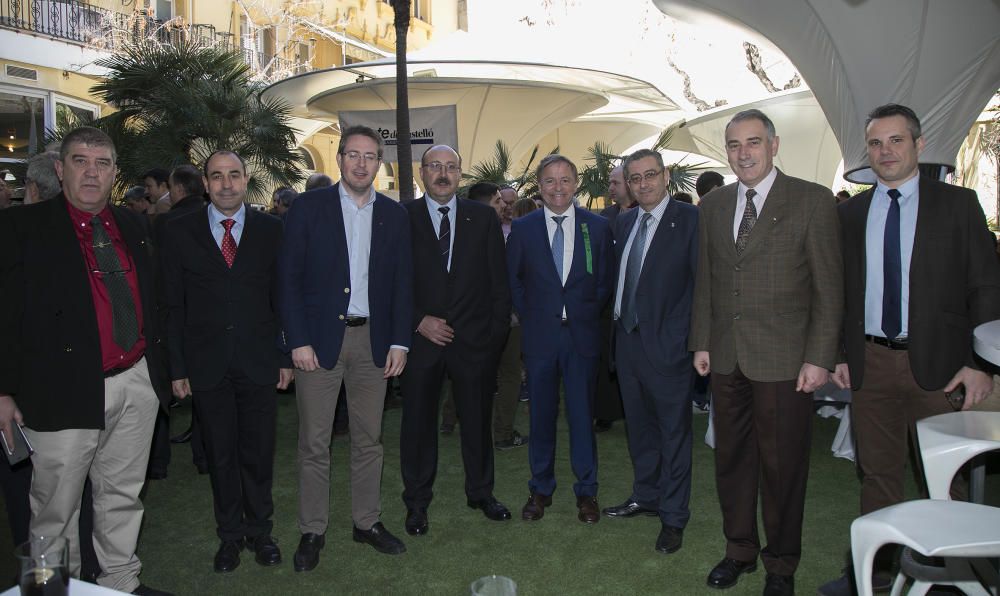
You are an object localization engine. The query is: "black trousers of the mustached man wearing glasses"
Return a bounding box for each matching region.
[399,349,497,509]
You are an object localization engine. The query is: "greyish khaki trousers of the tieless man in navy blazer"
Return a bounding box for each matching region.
[295,325,386,534]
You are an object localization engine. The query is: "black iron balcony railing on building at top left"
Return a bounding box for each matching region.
[0,0,312,80]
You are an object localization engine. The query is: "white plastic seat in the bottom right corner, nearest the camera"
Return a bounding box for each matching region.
[851,499,1000,596]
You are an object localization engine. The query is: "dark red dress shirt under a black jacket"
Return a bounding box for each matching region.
[66,203,146,372]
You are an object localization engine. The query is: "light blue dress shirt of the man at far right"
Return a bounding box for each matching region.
[865,175,920,337]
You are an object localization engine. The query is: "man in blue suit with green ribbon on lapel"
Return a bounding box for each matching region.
[507,154,614,523]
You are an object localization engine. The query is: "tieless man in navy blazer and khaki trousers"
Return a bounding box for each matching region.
[279,126,413,571]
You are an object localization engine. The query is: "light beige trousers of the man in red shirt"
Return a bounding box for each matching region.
[25,358,159,592]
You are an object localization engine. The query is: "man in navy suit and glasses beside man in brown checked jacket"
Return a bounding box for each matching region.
[604,149,698,553]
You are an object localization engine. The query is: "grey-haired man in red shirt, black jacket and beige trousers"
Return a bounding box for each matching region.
[0,127,169,594]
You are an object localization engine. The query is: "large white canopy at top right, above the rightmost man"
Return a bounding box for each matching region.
[653,0,1000,182]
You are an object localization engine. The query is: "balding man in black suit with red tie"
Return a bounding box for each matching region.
[161,151,292,573]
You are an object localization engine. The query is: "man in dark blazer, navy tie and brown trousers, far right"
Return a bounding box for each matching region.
[820,104,1000,595]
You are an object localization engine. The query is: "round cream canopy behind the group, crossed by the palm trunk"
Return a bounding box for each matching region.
[265,60,682,170]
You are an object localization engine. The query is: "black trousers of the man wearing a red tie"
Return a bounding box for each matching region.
[194,370,277,540]
